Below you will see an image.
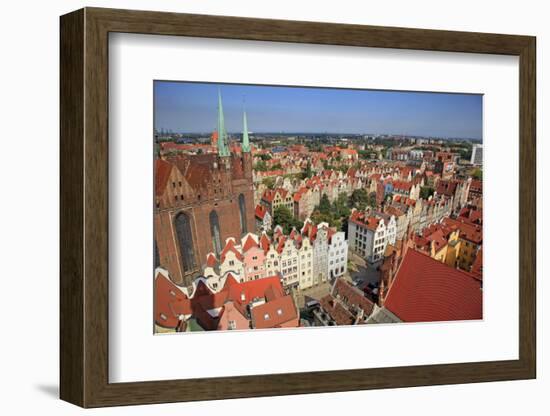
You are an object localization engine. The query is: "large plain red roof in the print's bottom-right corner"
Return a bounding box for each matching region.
[384,249,482,322]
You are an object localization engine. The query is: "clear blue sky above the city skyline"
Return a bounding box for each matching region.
[154,81,482,139]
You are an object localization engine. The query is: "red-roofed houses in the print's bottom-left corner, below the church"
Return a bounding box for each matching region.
[154,268,300,333]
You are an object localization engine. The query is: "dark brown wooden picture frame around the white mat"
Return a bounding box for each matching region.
[60,8,536,407]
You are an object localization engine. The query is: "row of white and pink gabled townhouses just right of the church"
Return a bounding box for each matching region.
[203,219,348,290]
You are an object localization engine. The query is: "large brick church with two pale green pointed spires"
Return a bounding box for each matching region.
[154,90,255,286]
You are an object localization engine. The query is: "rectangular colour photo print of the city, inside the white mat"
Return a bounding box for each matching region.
[152,81,483,333]
